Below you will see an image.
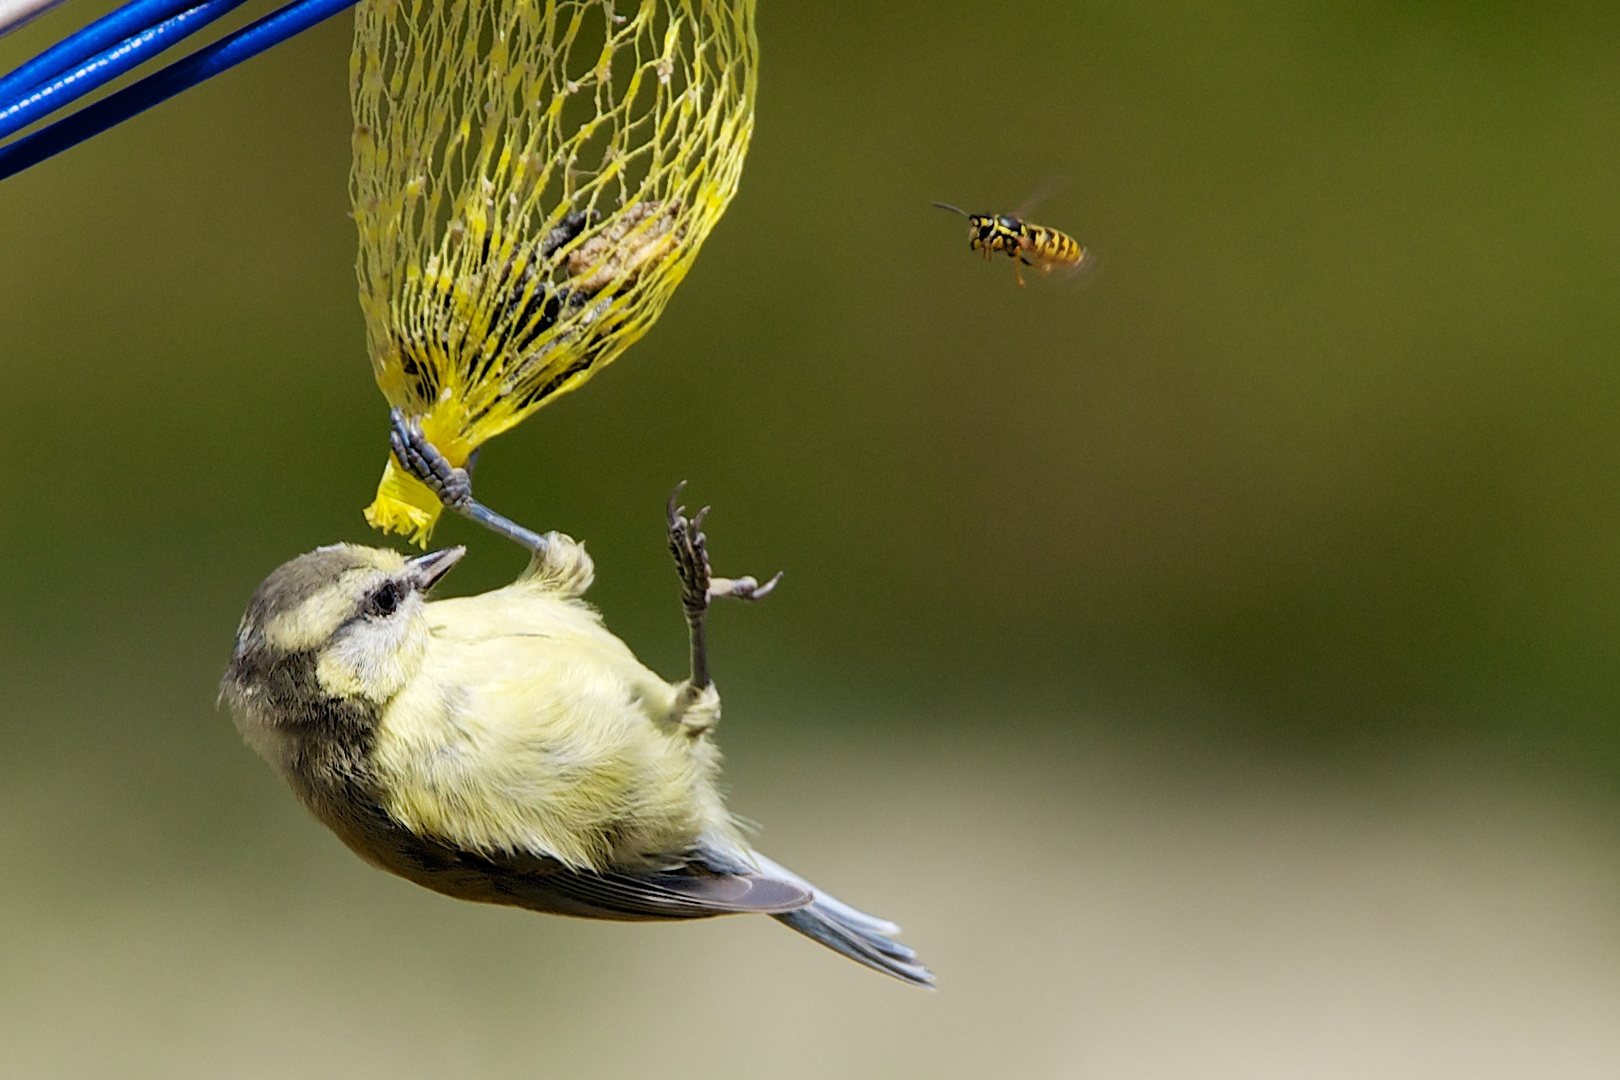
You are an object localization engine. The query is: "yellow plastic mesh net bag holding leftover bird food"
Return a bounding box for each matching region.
[350,0,758,542]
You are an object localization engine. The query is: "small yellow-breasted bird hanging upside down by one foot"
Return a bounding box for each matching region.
[220,410,933,986]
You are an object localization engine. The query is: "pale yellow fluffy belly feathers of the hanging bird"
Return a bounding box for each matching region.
[371,589,724,870]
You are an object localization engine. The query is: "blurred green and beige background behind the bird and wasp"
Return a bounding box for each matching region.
[0,0,1620,1078]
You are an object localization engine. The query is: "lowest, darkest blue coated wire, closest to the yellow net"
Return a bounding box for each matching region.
[0,0,356,180]
